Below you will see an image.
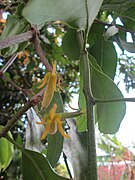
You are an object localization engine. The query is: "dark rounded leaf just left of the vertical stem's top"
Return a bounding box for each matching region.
[62,28,80,60]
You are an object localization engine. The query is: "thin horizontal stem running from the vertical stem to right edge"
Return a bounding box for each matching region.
[95,98,135,103]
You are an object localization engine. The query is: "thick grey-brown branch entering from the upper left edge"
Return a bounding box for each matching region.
[0,30,34,49]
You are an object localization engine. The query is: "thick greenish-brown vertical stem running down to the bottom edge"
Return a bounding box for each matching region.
[78,31,97,180]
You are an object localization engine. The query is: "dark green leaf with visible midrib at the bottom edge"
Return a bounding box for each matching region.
[22,149,67,180]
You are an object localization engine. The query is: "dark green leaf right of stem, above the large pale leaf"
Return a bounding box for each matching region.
[89,38,117,79]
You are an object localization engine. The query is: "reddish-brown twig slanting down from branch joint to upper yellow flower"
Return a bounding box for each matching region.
[32,27,52,72]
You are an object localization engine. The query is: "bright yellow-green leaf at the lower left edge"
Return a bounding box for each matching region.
[0,126,14,171]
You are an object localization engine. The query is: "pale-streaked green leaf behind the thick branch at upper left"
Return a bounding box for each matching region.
[0,15,28,57]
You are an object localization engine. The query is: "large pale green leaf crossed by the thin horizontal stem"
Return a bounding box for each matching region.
[90,56,126,134]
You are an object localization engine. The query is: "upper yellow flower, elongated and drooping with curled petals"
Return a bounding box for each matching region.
[38,62,60,109]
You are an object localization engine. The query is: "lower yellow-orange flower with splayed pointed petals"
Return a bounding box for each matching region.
[37,104,69,140]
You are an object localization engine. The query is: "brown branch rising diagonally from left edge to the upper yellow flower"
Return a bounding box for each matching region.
[0,89,44,138]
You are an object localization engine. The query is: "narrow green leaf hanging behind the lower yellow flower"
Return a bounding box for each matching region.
[47,92,63,167]
